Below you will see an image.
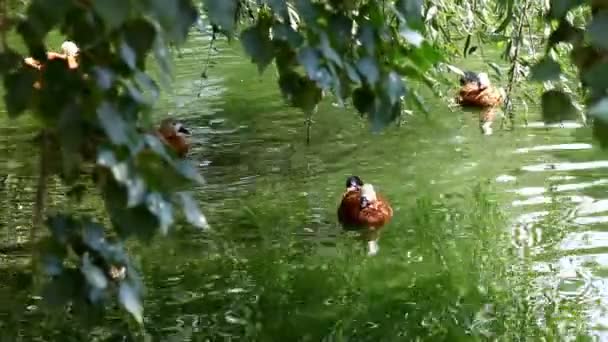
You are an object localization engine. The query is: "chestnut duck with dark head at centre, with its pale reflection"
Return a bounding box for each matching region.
[338,176,393,256]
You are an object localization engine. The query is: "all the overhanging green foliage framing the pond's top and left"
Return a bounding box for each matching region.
[0,0,608,328]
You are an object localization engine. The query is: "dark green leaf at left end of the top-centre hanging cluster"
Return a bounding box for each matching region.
[241,24,274,73]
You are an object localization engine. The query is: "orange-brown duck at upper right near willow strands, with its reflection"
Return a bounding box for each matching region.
[456,71,506,135]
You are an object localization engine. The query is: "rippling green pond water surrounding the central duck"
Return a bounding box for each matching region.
[0,30,608,341]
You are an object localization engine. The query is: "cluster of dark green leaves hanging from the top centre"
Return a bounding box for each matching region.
[223,0,432,125]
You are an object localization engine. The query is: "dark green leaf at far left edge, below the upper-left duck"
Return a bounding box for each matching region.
[4,68,38,118]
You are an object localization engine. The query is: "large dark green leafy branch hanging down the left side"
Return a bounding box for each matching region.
[0,0,207,323]
